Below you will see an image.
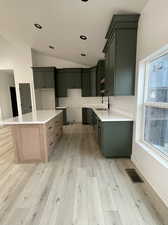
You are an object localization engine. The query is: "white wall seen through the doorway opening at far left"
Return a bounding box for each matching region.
[0,70,15,119]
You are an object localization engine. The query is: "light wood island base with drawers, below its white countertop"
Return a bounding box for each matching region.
[3,112,63,163]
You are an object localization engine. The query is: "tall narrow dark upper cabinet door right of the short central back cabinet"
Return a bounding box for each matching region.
[81,69,91,97]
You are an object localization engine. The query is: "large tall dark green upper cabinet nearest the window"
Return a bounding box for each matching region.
[103,15,139,96]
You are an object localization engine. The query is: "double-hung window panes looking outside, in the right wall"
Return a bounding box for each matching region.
[143,53,168,156]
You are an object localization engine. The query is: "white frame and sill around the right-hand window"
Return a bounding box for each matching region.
[136,45,168,160]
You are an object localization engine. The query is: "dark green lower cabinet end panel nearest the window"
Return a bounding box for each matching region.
[98,121,133,158]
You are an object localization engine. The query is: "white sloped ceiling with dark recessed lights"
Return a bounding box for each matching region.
[0,0,147,65]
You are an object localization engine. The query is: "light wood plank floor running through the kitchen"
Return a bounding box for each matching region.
[0,125,163,225]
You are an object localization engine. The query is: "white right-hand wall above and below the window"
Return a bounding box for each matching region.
[132,0,168,206]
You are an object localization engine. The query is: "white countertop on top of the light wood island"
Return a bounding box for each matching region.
[2,110,62,125]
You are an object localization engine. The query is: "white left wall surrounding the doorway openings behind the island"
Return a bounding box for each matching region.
[0,36,36,118]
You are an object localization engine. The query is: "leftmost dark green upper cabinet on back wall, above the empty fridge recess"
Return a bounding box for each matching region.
[32,67,56,89]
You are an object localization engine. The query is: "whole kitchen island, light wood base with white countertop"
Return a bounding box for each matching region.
[3,110,63,163]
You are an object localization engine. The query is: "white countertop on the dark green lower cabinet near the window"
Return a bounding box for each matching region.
[92,108,133,122]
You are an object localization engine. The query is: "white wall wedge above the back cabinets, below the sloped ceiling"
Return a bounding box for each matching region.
[32,50,89,68]
